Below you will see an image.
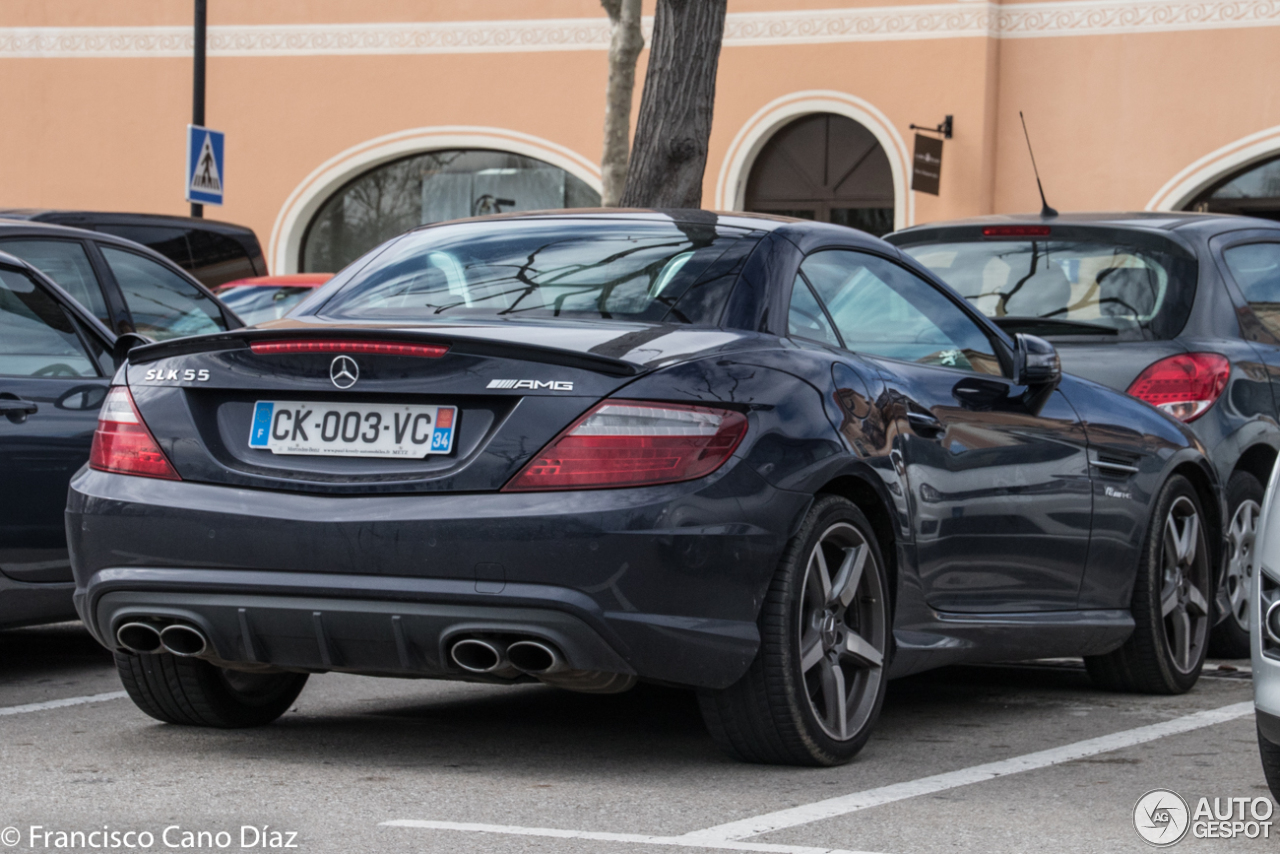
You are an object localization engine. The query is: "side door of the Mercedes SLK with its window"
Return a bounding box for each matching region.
[790,250,1092,613]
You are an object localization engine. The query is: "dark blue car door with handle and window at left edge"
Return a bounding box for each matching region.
[0,262,110,581]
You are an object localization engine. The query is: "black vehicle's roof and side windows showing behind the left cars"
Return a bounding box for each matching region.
[0,207,266,288]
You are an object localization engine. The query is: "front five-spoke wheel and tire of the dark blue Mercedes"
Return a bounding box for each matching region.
[1084,475,1213,694]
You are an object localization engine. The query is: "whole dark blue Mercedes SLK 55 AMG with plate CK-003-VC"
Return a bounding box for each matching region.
[67,211,1222,764]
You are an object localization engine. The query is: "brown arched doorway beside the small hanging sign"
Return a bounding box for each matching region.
[745,113,893,236]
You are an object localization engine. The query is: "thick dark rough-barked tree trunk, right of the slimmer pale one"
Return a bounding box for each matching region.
[620,0,726,207]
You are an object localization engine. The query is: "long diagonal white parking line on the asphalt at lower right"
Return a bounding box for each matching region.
[685,700,1253,840]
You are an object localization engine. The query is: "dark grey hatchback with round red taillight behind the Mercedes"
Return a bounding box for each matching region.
[887,214,1280,658]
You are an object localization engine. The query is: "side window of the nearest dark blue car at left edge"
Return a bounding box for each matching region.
[0,270,97,376]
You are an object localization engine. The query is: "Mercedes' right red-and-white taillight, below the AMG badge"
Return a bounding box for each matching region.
[503,401,746,492]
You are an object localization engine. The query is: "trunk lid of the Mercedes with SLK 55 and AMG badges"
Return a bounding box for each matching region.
[127,319,756,493]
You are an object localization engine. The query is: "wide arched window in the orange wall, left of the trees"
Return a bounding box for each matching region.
[298,149,600,273]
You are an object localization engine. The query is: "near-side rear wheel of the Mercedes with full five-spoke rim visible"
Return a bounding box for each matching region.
[699,495,892,766]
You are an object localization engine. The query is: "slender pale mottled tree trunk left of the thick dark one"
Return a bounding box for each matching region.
[600,0,644,207]
